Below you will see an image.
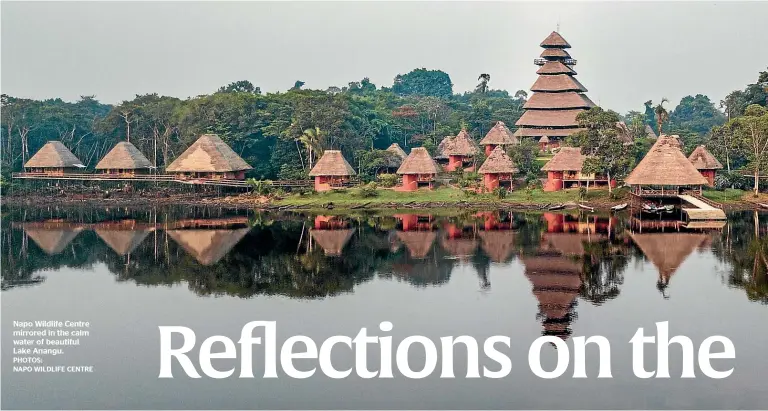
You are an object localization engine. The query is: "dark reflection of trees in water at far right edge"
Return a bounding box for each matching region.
[712,211,768,304]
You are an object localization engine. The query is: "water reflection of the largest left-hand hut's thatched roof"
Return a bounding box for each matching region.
[168,228,249,265]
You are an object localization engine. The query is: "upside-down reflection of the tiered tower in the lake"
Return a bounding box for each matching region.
[522,255,581,340]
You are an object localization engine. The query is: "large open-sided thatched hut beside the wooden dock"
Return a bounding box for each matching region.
[624,134,708,197]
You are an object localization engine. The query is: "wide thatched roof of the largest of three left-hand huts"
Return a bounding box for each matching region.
[165,134,252,173]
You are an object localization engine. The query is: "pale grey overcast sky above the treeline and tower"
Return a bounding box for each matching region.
[0,2,768,112]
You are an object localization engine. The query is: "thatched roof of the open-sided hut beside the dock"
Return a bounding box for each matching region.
[624,135,707,186]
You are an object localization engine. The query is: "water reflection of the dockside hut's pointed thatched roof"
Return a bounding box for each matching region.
[630,233,707,280]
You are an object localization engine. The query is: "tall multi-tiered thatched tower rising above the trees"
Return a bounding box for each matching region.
[514,31,595,149]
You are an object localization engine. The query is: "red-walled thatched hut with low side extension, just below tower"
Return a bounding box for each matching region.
[541,147,616,191]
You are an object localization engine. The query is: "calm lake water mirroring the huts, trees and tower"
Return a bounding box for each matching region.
[2,208,768,409]
